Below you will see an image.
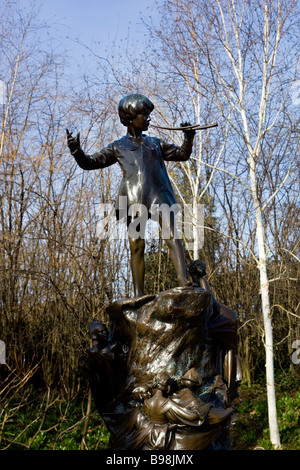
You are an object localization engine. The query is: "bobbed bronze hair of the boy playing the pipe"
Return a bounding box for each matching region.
[118,93,154,126]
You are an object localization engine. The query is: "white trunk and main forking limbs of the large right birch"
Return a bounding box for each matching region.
[217,0,280,449]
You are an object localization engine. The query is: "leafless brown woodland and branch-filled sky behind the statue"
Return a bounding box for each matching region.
[0,0,300,448]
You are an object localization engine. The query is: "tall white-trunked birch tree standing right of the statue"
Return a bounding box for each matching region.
[198,0,297,449]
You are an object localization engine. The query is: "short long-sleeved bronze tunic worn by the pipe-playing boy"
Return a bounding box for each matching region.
[73,134,192,212]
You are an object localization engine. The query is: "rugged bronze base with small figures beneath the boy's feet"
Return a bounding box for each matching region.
[82,262,241,450]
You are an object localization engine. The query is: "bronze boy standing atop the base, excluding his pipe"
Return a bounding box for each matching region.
[67,94,195,297]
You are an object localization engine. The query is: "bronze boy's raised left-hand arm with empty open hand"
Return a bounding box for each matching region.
[66,129,117,170]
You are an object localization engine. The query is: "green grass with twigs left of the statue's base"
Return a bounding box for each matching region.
[0,390,109,450]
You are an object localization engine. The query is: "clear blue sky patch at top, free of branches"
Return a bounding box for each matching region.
[37,0,155,60]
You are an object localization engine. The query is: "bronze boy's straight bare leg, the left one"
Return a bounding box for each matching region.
[129,237,145,297]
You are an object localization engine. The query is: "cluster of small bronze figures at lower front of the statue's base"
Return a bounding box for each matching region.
[122,369,233,450]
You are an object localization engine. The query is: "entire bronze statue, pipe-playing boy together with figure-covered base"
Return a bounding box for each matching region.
[67,94,240,450]
